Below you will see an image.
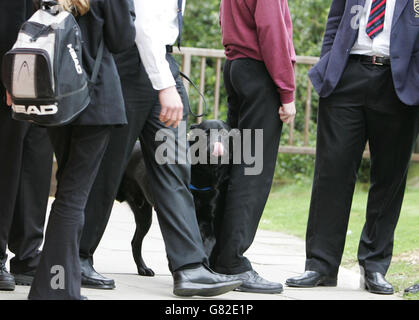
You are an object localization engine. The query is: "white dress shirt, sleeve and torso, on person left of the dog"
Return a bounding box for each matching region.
[135,0,186,90]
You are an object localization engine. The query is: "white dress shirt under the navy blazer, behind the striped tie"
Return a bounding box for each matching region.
[351,0,396,57]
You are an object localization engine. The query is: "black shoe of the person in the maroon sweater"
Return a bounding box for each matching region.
[231,270,284,293]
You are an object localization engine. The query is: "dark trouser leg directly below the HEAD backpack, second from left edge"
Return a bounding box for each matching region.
[9,125,53,273]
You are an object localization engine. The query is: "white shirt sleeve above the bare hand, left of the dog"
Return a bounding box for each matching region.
[134,0,176,90]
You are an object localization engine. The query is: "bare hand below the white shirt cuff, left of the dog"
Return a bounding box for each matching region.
[159,86,183,128]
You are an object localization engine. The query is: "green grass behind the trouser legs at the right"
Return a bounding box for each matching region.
[260,165,419,300]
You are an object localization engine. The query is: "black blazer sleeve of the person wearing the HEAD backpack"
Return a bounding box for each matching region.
[103,0,135,54]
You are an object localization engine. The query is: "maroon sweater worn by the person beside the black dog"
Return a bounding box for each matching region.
[220,0,296,103]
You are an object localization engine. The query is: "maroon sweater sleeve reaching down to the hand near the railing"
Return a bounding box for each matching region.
[254,0,296,103]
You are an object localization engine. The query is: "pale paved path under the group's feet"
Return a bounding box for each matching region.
[0,202,400,300]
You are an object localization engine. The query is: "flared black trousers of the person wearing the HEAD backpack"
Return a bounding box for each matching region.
[29,125,111,300]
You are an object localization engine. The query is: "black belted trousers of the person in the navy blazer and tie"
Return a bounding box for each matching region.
[306,58,419,276]
